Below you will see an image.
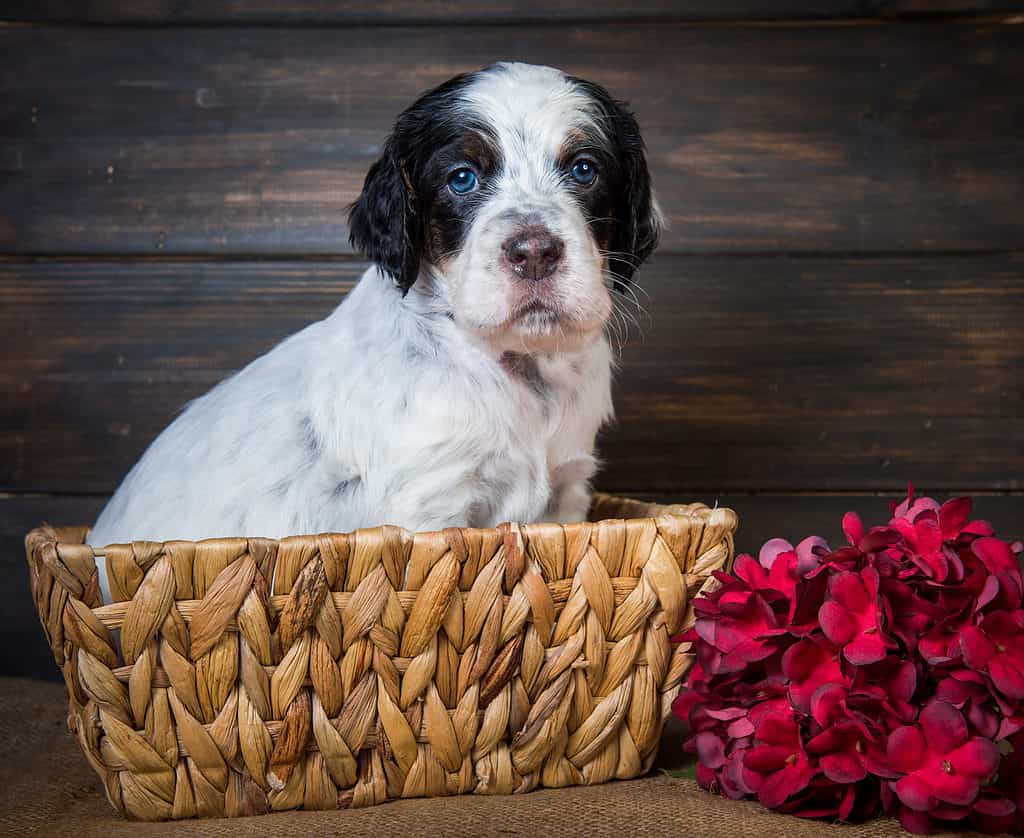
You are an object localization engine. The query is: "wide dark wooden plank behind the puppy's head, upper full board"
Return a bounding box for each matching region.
[0,23,1024,250]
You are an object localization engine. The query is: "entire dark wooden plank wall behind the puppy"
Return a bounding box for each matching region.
[0,0,1024,677]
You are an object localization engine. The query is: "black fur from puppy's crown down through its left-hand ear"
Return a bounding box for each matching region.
[348,73,475,294]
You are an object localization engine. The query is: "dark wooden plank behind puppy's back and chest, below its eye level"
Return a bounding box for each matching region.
[0,250,1024,492]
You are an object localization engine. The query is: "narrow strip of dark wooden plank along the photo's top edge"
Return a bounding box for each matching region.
[0,0,1021,26]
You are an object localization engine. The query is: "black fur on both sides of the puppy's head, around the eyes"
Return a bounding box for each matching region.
[349,69,658,293]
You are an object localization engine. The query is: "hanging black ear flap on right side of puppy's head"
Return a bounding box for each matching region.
[608,101,663,285]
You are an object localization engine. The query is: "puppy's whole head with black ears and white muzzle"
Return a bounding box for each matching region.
[349,64,659,351]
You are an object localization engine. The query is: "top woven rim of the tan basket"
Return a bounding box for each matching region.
[25,492,739,558]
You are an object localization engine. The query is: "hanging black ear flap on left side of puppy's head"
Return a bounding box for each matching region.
[348,145,423,294]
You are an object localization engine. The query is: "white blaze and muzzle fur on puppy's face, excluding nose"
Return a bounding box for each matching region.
[444,64,611,351]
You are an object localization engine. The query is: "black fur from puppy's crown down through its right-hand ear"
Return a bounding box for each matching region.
[571,78,662,286]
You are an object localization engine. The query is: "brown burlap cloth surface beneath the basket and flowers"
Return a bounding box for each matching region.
[0,678,983,838]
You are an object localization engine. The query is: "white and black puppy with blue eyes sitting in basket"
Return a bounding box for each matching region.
[89,64,659,561]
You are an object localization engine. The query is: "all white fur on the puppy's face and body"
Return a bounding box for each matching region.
[89,65,638,596]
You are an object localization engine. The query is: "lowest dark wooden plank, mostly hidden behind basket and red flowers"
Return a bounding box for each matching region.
[6,489,1024,680]
